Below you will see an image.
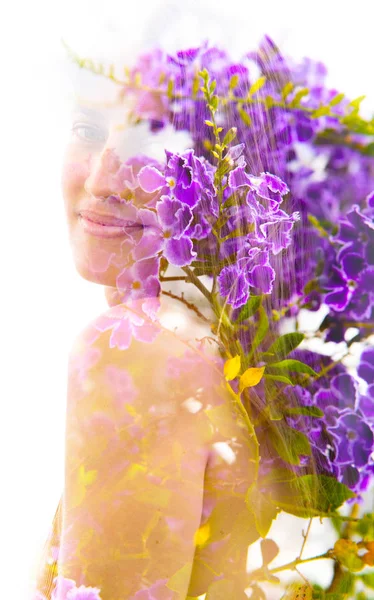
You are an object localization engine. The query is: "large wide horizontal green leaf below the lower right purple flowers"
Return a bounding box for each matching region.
[270,475,356,519]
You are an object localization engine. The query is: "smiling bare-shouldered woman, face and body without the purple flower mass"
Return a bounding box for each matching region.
[31,43,258,600]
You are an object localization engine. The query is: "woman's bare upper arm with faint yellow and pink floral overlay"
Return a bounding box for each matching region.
[57,328,213,600]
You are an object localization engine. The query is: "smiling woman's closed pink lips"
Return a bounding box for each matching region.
[79,210,144,238]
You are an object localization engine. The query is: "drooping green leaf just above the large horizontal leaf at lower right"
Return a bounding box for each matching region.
[268,422,311,465]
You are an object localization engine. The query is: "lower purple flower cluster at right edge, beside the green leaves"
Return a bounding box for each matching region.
[274,349,374,493]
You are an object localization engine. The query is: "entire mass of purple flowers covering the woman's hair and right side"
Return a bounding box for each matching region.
[117,38,374,490]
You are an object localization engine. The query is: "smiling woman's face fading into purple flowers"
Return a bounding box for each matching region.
[62,92,164,287]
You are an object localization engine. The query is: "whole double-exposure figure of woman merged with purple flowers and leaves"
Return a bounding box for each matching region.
[32,37,374,600]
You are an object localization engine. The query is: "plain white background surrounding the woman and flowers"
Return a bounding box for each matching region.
[0,0,374,600]
